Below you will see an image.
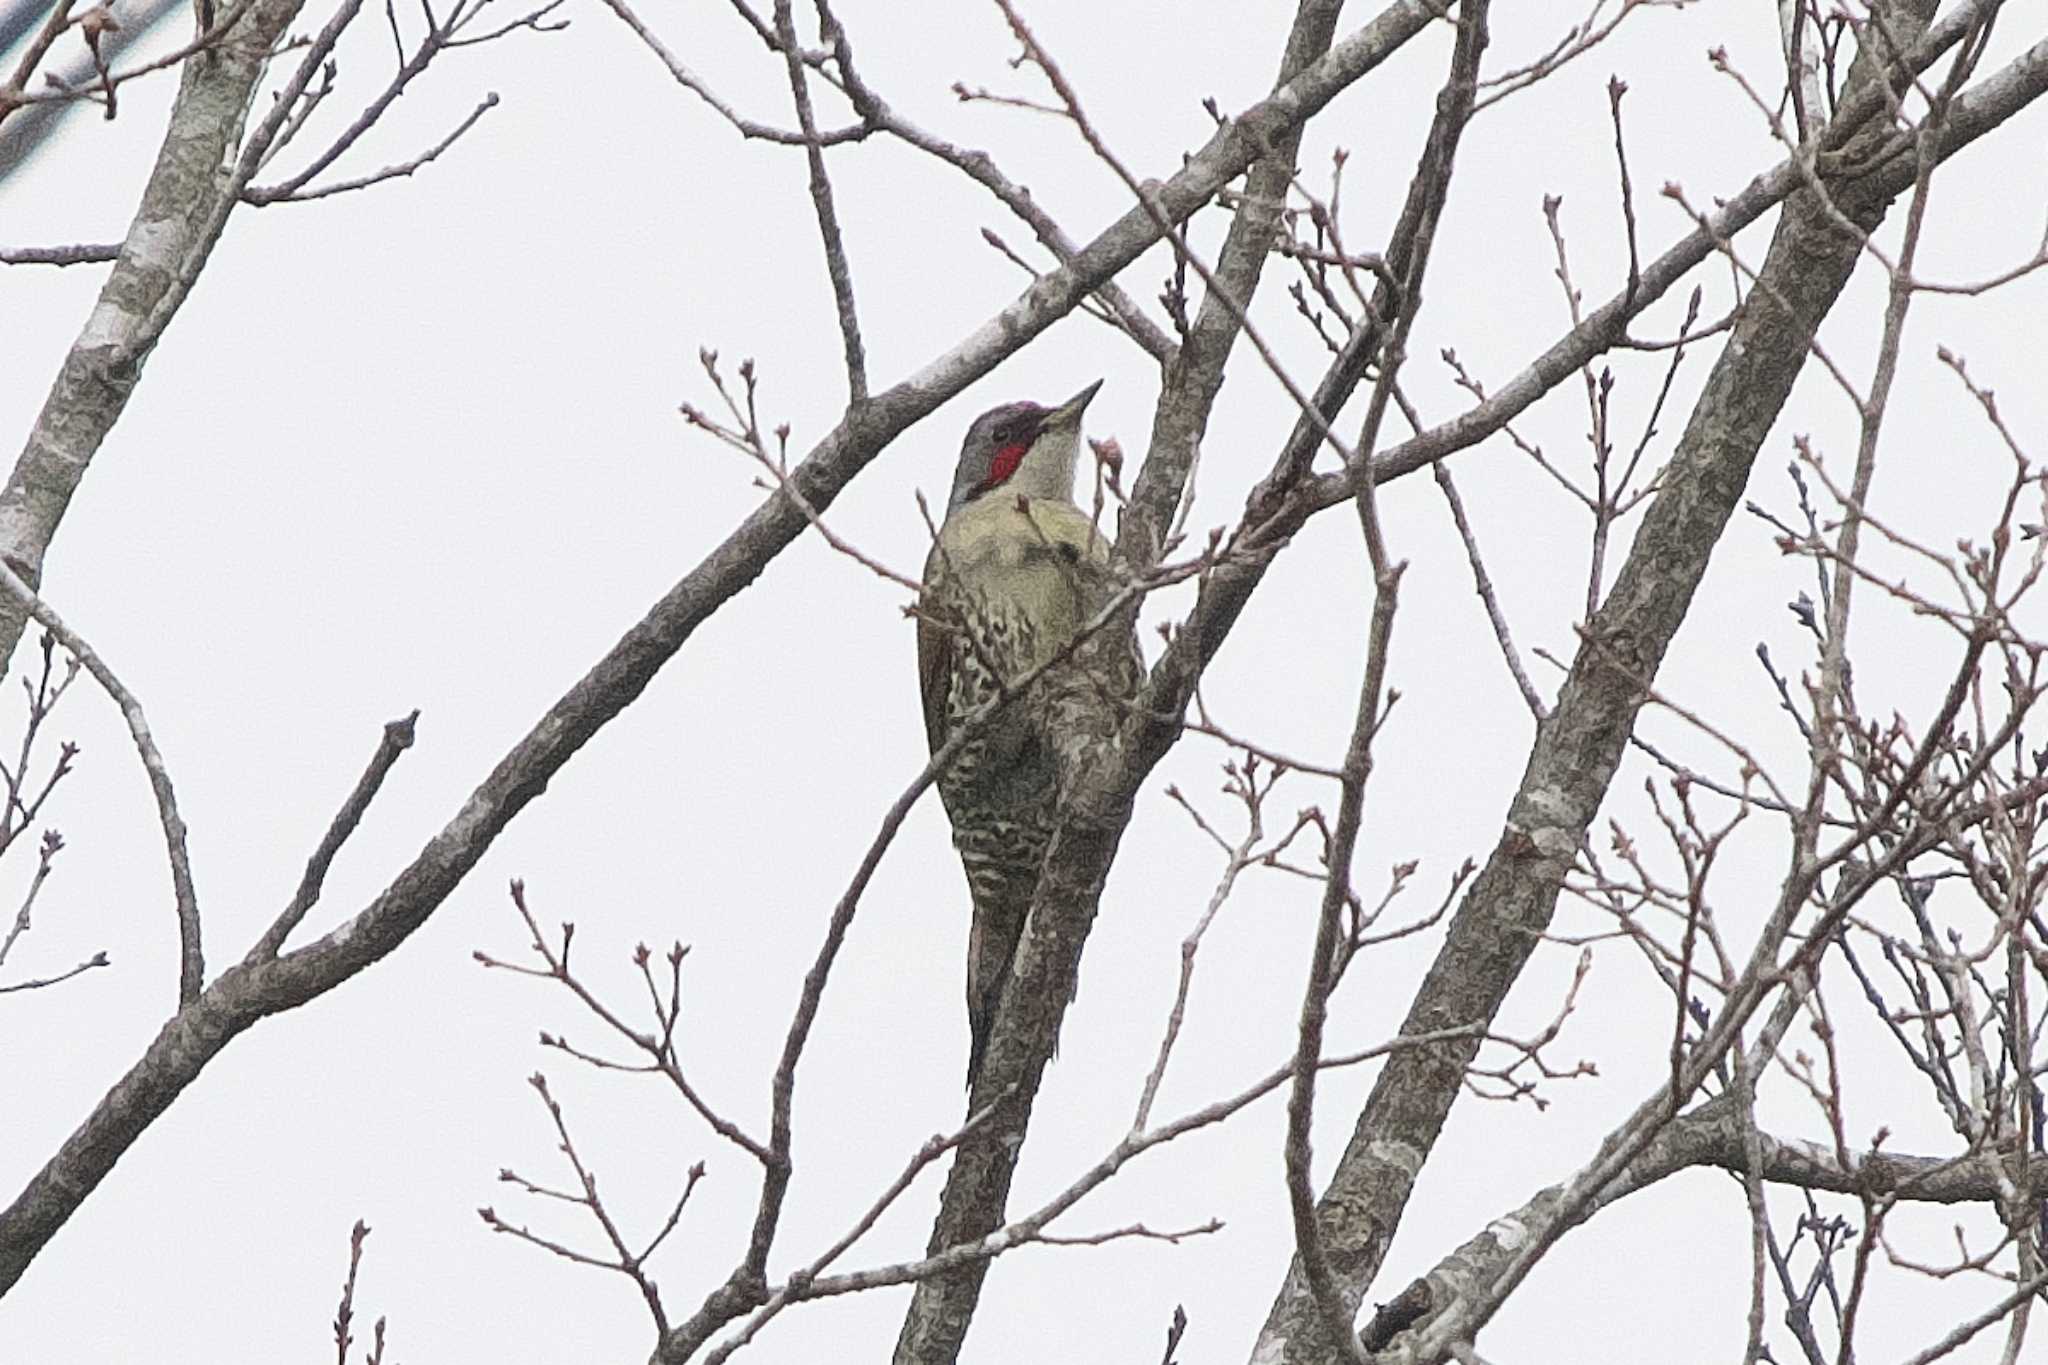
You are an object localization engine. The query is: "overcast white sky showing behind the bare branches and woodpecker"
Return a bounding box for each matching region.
[0,0,2048,1365]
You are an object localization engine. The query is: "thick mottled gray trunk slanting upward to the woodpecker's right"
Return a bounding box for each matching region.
[1251,4,1966,1365]
